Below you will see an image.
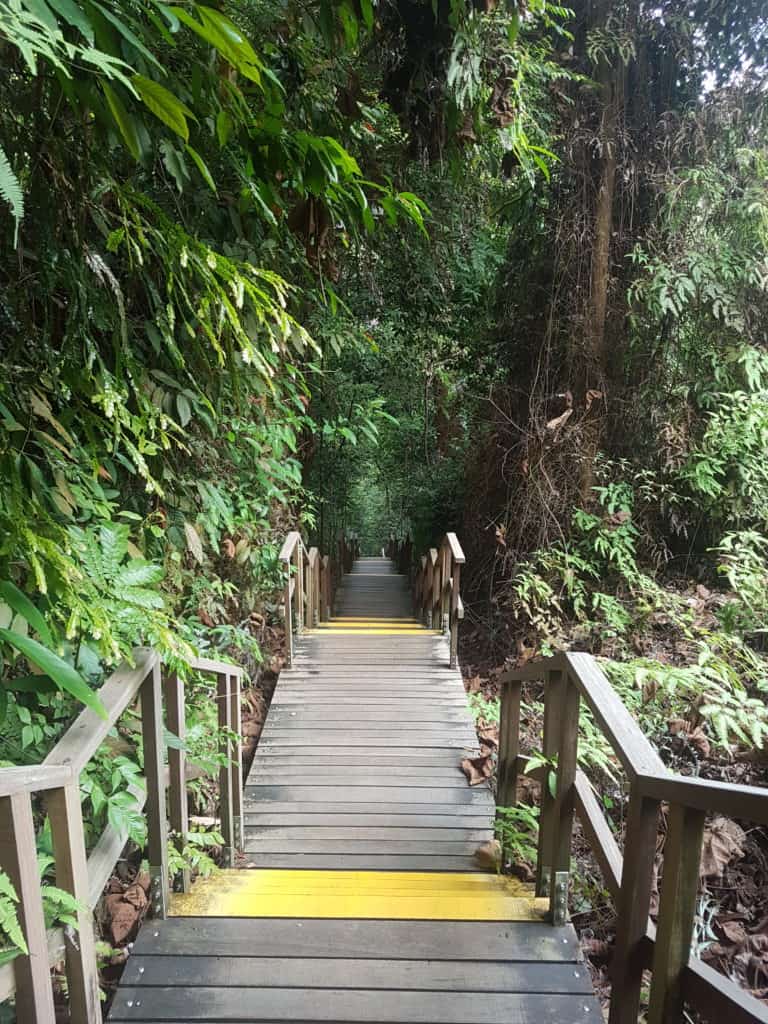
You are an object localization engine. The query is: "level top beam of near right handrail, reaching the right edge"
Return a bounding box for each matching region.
[640,772,768,825]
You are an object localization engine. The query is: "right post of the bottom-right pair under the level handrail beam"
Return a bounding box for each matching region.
[648,804,707,1024]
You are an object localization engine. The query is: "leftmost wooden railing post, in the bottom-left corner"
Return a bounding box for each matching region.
[0,792,55,1024]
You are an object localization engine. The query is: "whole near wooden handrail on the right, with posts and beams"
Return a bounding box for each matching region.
[497,653,768,1024]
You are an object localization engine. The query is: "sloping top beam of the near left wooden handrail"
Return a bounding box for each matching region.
[43,647,160,775]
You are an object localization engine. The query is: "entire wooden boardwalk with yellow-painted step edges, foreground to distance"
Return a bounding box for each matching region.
[110,559,602,1024]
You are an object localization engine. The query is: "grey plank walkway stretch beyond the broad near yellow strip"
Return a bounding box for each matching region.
[244,558,495,871]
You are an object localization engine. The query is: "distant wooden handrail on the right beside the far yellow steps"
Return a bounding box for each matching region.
[411,534,466,669]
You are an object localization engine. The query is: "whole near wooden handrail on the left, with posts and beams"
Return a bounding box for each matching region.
[0,647,244,1024]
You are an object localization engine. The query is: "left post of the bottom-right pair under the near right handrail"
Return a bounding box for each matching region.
[608,779,658,1024]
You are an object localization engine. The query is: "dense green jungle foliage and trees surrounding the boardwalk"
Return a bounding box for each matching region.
[0,0,768,1007]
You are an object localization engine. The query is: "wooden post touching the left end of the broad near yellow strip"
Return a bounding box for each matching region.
[139,662,168,918]
